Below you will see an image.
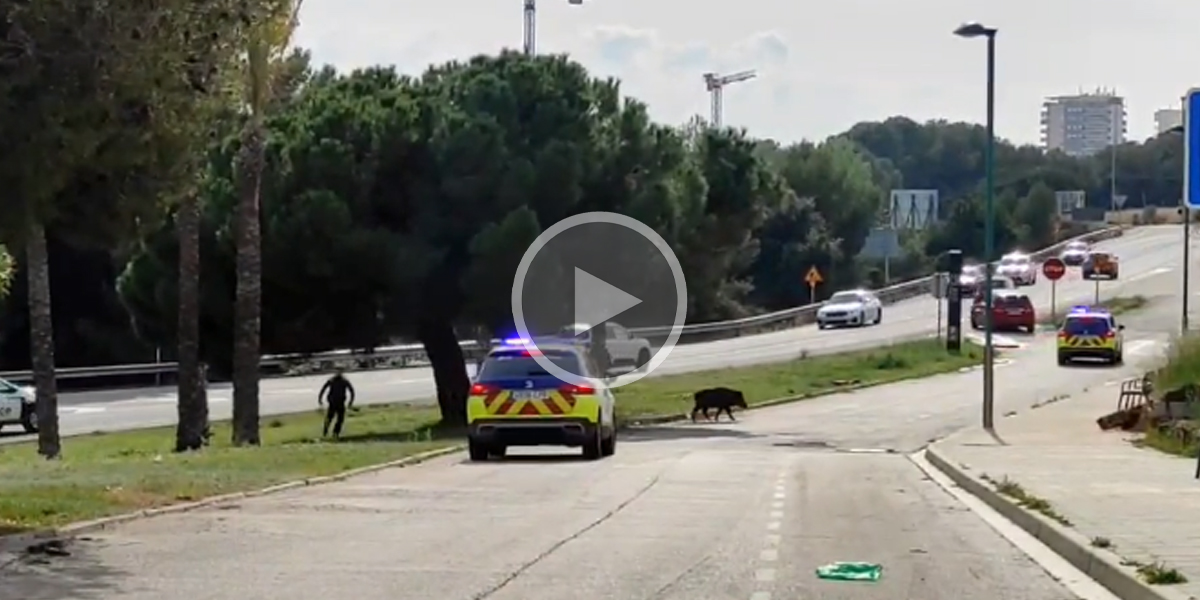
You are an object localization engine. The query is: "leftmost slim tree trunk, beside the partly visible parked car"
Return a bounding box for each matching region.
[25,222,62,458]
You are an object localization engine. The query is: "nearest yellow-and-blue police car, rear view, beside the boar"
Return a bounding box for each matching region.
[467,340,617,461]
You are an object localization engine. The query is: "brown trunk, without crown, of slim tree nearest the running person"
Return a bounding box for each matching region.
[233,118,264,445]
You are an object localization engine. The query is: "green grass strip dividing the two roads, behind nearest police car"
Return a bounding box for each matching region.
[0,341,982,534]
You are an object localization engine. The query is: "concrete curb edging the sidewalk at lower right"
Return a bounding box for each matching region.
[924,444,1192,600]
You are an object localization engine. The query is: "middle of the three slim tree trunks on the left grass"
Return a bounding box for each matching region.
[175,192,209,452]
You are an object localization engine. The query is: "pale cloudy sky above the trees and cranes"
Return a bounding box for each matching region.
[295,0,1200,143]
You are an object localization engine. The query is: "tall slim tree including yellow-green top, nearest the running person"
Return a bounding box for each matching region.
[233,0,302,445]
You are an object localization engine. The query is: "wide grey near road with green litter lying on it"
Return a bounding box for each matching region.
[0,249,1178,600]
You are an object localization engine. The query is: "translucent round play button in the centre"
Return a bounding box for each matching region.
[512,212,688,388]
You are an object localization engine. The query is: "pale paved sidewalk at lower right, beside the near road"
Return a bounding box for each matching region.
[926,386,1200,600]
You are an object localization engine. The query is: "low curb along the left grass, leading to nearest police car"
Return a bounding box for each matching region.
[0,444,466,551]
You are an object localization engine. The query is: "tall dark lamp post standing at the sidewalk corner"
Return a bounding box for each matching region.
[954,23,997,431]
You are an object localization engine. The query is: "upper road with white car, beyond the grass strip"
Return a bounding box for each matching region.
[7,226,1182,442]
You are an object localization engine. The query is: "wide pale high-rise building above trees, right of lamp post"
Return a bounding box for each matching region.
[1042,90,1127,156]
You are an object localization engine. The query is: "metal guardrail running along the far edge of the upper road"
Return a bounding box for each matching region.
[0,227,1124,382]
